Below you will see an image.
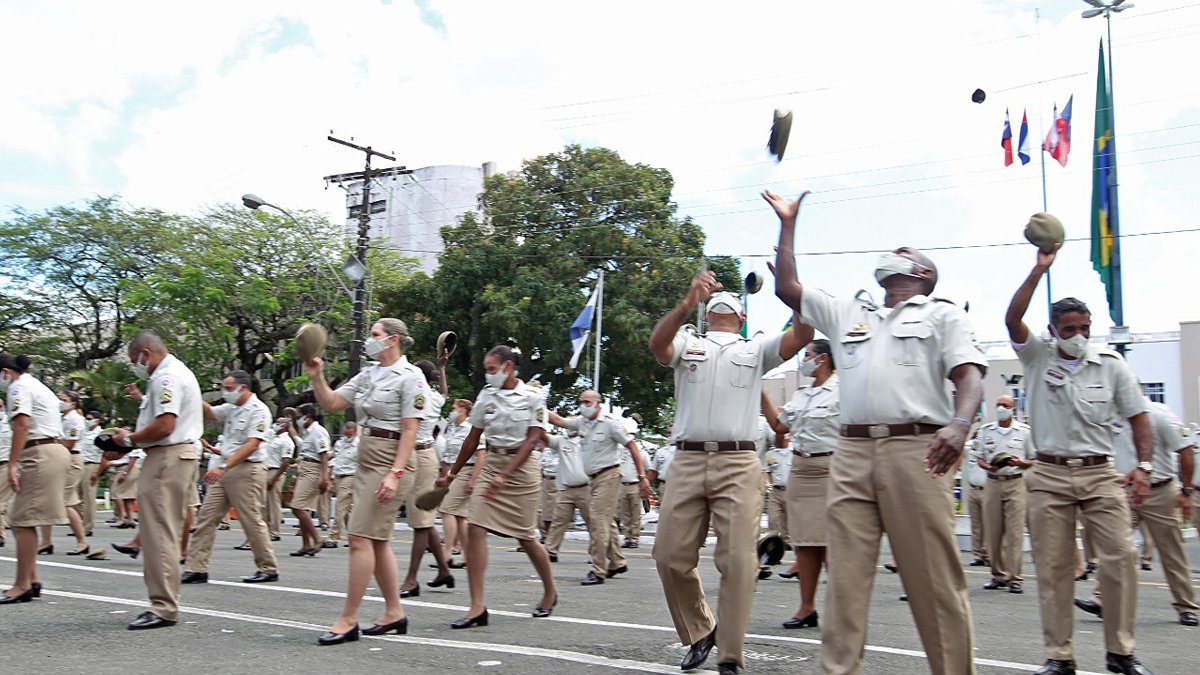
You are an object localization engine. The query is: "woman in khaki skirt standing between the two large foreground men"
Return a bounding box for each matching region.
[763,340,840,628]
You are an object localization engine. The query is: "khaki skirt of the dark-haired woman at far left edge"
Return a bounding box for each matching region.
[4,443,70,527]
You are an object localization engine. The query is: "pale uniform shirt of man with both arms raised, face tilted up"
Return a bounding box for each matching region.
[666,327,784,442]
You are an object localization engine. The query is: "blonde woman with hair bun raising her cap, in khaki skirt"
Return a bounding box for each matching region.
[306,318,428,645]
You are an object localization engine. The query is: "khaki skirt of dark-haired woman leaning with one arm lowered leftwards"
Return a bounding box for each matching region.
[467,452,541,539]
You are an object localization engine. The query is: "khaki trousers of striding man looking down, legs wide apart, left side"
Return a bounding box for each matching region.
[187,461,280,574]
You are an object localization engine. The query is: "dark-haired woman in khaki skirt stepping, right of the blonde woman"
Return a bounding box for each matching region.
[438,345,558,628]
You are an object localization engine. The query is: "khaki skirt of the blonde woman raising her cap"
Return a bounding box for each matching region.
[346,435,418,542]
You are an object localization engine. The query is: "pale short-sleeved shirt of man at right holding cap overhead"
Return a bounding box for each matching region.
[1013,336,1150,458]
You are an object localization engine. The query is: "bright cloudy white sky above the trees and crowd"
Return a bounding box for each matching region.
[0,0,1200,340]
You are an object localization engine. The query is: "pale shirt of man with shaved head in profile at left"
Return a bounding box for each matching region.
[137,354,204,451]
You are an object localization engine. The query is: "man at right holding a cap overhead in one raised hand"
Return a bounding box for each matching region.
[1004,242,1154,675]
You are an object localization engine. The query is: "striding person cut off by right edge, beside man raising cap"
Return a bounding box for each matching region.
[1075,401,1200,626]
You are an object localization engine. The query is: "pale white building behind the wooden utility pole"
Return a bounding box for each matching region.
[329,162,494,274]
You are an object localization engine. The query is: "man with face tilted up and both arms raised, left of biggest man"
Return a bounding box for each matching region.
[649,273,806,673]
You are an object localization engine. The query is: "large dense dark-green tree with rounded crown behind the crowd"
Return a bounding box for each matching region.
[380,145,740,426]
